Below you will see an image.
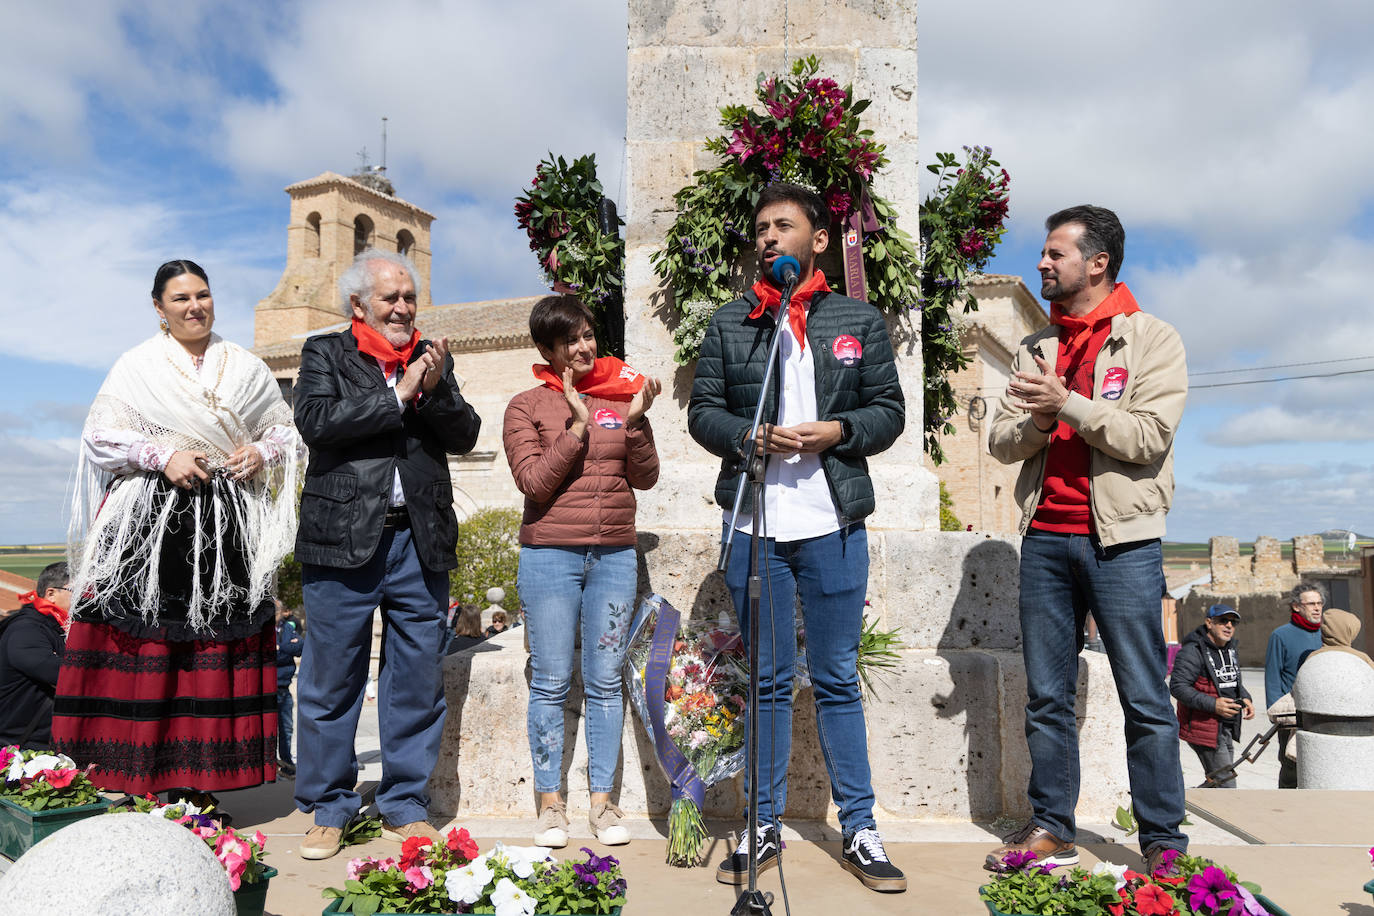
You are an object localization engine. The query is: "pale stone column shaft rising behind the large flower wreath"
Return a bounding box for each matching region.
[624,0,938,531]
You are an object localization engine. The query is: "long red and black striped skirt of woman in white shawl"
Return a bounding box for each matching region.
[52,618,276,795]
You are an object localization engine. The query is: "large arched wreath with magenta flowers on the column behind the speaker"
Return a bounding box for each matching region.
[653,56,919,364]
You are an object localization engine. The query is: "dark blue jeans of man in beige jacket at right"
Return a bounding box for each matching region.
[1021,529,1189,851]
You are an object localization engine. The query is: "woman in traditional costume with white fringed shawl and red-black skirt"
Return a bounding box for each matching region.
[52,261,302,794]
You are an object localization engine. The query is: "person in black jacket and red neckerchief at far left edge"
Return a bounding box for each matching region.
[0,563,71,747]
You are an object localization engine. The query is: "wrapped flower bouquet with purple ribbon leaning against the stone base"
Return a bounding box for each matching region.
[625,595,749,868]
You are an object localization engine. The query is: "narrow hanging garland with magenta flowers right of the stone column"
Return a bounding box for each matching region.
[921,147,1011,464]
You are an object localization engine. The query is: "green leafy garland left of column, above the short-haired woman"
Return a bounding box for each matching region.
[515,154,625,317]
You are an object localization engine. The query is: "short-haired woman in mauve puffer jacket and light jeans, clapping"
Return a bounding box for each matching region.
[502,295,661,846]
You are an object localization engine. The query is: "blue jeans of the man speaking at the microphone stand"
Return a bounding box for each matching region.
[725,523,875,835]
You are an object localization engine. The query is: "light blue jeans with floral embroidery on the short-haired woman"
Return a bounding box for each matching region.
[518,544,639,792]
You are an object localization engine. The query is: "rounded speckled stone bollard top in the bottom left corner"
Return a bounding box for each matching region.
[0,814,235,916]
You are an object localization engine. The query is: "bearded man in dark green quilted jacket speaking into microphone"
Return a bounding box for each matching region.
[687,183,907,891]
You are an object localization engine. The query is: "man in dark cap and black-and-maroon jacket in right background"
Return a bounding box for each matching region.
[1169,604,1254,788]
